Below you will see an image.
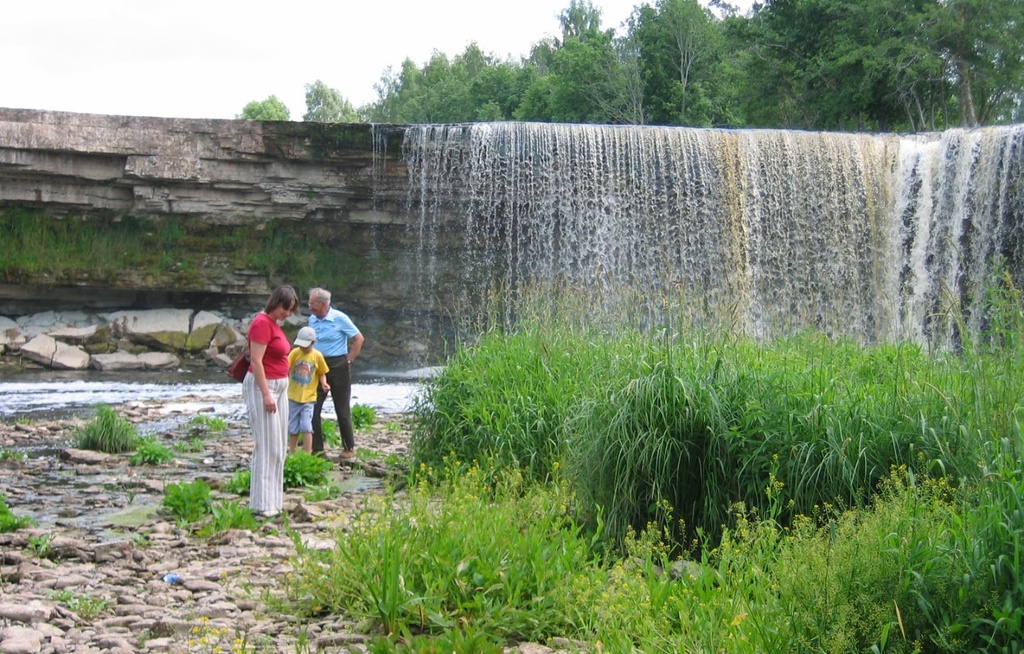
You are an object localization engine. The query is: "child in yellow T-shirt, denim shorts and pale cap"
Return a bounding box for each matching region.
[288,326,331,454]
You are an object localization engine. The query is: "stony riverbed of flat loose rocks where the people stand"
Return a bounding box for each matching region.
[0,398,410,654]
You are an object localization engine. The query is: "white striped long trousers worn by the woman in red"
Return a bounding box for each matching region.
[242,373,288,513]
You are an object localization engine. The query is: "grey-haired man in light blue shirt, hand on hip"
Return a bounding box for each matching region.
[309,289,364,459]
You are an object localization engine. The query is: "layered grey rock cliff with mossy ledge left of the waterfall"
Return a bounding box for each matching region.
[0,108,431,370]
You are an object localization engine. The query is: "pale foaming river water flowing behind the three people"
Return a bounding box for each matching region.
[0,368,432,421]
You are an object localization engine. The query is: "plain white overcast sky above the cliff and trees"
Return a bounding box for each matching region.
[0,0,751,121]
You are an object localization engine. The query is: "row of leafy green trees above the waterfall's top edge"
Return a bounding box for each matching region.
[239,0,1024,132]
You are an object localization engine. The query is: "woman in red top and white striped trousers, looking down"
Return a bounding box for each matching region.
[242,287,298,518]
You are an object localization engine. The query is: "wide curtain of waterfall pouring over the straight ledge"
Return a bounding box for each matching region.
[402,123,1024,345]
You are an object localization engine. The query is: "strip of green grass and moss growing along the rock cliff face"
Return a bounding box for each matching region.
[0,209,368,309]
